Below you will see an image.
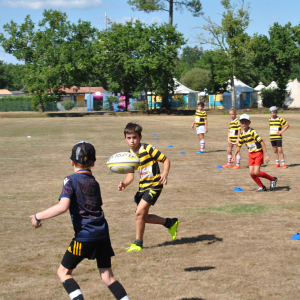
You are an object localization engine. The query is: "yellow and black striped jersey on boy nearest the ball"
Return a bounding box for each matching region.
[130,143,166,192]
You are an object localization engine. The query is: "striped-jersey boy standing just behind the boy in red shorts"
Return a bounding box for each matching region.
[222,108,241,169]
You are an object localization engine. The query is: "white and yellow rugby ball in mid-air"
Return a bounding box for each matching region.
[106,152,140,174]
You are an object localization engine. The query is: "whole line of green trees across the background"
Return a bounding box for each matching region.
[0,0,300,110]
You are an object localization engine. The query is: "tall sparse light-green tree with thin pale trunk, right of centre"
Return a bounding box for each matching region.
[199,0,252,107]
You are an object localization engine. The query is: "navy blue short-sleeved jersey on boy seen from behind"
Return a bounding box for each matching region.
[59,169,109,242]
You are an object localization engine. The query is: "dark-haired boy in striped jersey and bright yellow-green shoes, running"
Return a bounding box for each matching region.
[118,123,179,252]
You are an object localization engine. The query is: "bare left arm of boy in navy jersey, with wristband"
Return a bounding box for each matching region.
[29,197,71,228]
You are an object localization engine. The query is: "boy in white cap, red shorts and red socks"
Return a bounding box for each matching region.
[232,114,277,192]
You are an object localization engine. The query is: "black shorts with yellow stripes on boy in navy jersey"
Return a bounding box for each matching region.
[61,239,115,270]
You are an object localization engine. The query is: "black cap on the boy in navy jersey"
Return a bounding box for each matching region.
[70,141,96,166]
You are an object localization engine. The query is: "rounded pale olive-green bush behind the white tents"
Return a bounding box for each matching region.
[180,68,211,91]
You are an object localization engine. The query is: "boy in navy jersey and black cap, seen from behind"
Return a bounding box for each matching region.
[30,142,129,300]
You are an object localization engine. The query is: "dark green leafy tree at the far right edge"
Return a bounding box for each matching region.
[252,23,300,106]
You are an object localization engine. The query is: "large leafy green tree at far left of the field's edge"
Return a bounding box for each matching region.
[0,10,98,111]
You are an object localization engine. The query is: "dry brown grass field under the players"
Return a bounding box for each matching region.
[0,114,300,300]
